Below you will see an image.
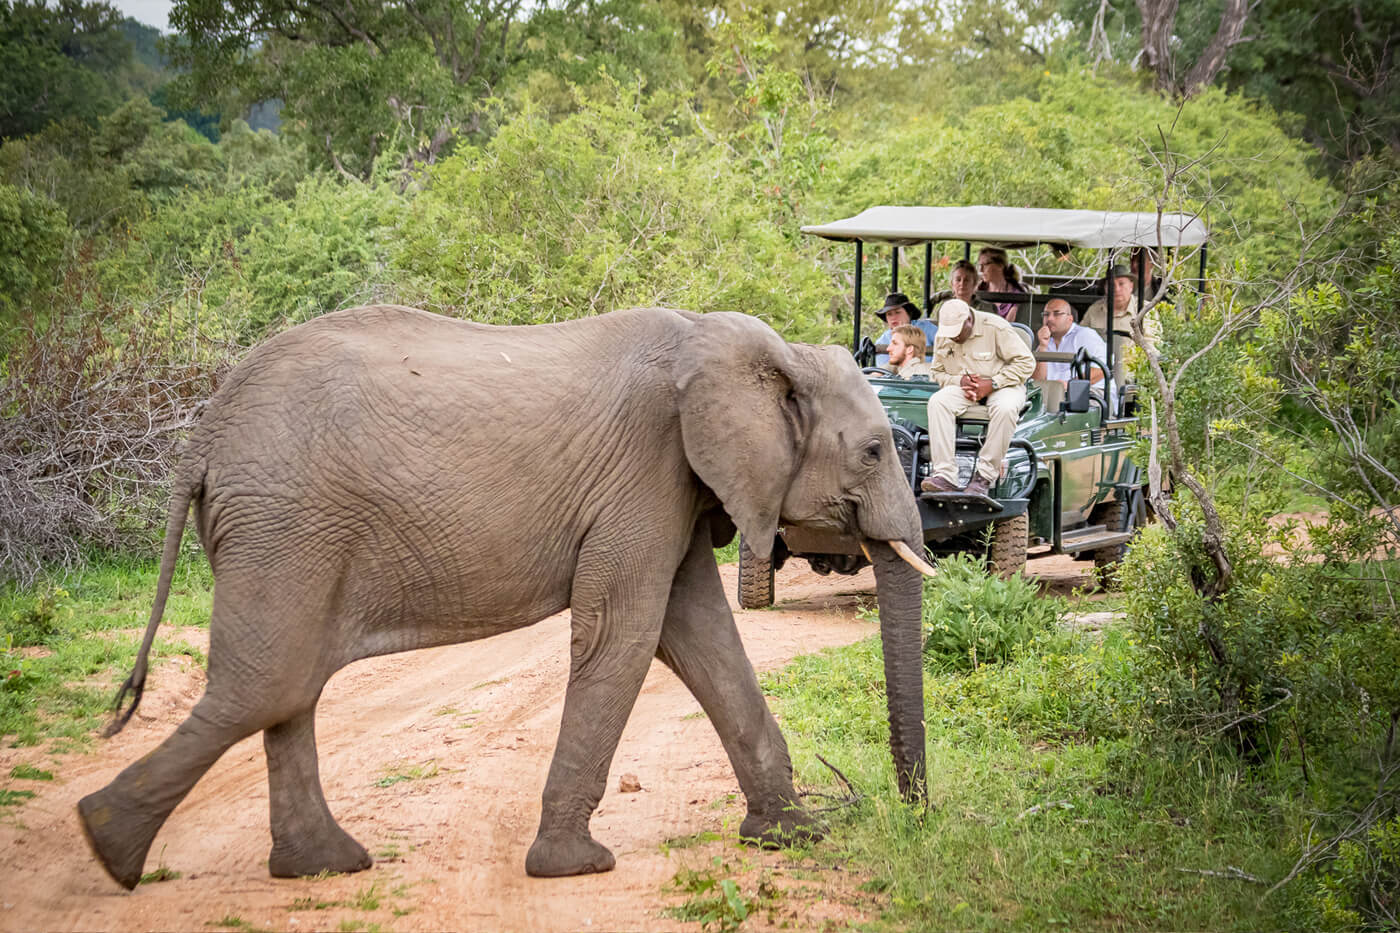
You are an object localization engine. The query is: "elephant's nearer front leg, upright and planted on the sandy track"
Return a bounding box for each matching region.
[525,537,669,877]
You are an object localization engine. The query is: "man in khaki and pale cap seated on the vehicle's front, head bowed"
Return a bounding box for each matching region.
[921,298,1036,496]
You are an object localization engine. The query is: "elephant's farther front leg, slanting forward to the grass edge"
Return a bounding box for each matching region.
[657,523,822,846]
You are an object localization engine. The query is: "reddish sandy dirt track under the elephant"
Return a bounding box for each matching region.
[0,558,1091,932]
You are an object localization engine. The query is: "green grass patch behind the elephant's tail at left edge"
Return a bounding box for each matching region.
[0,553,213,745]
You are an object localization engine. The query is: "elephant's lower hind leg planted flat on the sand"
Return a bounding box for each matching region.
[263,705,374,878]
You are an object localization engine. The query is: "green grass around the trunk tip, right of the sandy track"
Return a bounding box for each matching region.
[764,630,1291,930]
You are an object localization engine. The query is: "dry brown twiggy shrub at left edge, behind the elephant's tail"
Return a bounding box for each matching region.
[0,296,227,583]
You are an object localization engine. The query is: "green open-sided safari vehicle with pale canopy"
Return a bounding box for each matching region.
[739,206,1208,608]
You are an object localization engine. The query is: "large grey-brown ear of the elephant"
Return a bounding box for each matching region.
[676,312,804,558]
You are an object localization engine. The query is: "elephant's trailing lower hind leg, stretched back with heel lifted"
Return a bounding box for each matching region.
[78,692,260,890]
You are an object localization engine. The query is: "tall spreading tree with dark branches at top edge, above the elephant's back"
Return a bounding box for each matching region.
[169,0,691,178]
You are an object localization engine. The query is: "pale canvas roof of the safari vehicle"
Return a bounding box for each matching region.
[802,205,1210,249]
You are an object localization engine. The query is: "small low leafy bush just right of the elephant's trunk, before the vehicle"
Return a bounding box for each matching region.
[924,555,1064,671]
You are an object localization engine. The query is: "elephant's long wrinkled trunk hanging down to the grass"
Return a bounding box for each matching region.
[868,541,927,803]
